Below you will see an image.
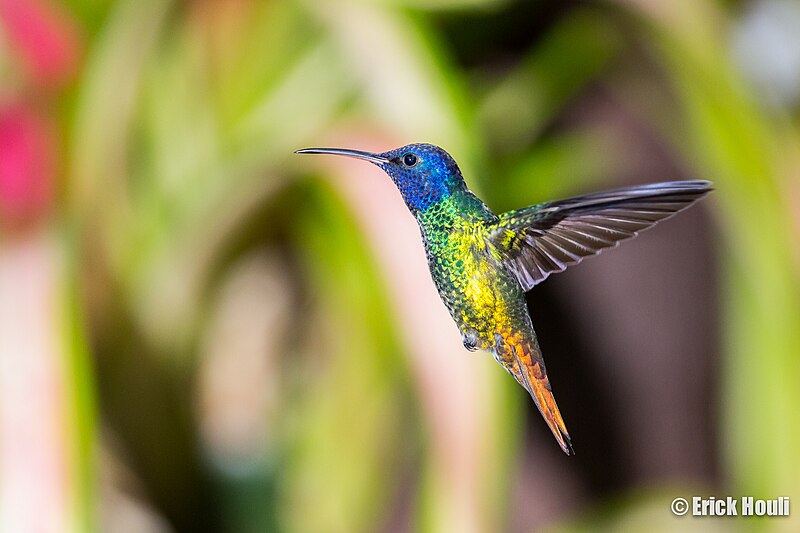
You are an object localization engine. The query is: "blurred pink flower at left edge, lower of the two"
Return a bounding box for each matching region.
[0,104,54,230]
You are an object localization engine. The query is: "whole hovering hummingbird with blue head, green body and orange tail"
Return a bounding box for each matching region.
[295,144,711,455]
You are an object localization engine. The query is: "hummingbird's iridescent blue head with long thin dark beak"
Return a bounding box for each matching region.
[295,144,466,213]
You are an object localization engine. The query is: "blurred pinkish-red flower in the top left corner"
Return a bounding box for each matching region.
[0,0,81,86]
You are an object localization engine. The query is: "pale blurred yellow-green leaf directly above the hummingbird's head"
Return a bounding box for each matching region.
[313,2,480,175]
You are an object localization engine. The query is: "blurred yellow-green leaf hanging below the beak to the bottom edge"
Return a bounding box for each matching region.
[282,182,412,532]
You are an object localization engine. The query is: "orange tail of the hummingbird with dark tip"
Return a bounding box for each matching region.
[503,332,575,455]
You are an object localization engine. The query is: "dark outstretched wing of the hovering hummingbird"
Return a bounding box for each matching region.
[489,181,711,291]
